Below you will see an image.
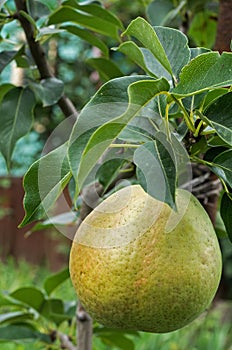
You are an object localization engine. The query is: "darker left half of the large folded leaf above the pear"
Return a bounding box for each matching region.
[68,76,148,185]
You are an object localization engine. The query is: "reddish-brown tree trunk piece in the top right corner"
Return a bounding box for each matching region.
[214,0,232,52]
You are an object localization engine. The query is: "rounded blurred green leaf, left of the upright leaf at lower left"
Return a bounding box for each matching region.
[10,287,45,311]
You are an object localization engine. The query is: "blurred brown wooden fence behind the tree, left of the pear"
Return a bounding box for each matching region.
[0,177,71,270]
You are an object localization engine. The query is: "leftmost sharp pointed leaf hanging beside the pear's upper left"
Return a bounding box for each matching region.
[19,144,71,227]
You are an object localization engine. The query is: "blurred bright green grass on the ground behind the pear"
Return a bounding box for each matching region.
[0,258,232,350]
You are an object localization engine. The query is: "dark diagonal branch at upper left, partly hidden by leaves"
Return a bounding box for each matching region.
[15,0,77,117]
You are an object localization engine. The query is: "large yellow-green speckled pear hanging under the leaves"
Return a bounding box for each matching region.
[70,185,222,333]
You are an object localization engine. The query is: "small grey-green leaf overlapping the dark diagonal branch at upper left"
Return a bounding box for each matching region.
[31,78,64,107]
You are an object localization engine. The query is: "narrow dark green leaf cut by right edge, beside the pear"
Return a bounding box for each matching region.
[220,192,232,242]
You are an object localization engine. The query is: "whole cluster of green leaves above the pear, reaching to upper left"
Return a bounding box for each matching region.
[0,0,232,237]
